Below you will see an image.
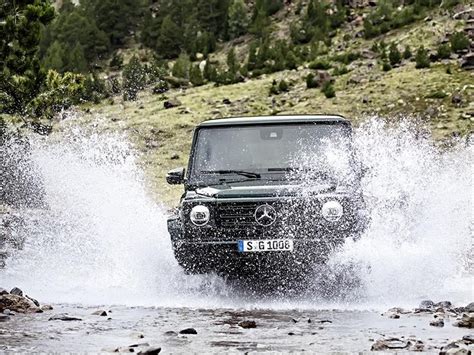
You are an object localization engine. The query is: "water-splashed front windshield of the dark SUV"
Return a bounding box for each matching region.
[190,123,351,182]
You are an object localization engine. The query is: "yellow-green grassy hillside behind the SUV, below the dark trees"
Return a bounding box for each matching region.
[51,2,474,205]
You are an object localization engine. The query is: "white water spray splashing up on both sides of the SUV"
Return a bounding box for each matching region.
[0,119,472,308]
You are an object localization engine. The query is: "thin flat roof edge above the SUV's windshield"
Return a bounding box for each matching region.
[198,115,349,127]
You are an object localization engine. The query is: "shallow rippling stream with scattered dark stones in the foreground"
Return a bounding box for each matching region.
[0,288,474,354]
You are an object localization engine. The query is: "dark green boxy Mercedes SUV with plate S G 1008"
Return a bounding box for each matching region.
[166,115,367,275]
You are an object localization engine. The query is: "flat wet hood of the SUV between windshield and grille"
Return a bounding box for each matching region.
[196,184,337,198]
